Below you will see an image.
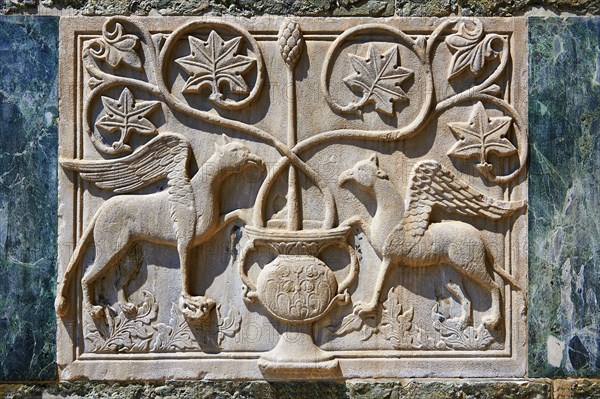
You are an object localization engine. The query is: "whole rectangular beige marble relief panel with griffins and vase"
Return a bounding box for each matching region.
[55,17,527,380]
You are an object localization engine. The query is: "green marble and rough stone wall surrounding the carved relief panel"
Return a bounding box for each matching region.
[0,0,600,399]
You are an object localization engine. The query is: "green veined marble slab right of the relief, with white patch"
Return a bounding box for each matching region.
[529,18,600,377]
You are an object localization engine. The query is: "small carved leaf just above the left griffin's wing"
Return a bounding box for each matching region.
[96,88,160,148]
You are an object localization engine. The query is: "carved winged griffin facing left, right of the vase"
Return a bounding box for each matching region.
[339,154,526,328]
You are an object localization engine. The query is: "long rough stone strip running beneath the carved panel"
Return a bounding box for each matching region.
[0,381,552,399]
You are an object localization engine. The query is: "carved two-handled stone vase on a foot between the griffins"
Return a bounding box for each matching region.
[240,226,358,375]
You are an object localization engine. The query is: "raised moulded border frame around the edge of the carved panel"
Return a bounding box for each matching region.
[57,17,527,380]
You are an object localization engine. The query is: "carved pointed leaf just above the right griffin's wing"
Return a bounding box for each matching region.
[448,102,517,164]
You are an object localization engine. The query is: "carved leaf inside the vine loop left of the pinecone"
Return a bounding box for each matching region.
[175,31,256,100]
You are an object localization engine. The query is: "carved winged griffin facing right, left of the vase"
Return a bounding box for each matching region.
[56,133,263,321]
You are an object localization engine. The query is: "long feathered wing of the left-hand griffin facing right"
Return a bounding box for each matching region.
[60,133,191,194]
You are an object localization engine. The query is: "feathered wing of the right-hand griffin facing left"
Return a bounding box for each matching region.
[403,161,527,236]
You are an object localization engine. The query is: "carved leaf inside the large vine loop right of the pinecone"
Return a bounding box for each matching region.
[344,45,413,115]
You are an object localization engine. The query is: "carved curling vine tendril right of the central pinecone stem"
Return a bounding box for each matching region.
[318,19,528,185]
